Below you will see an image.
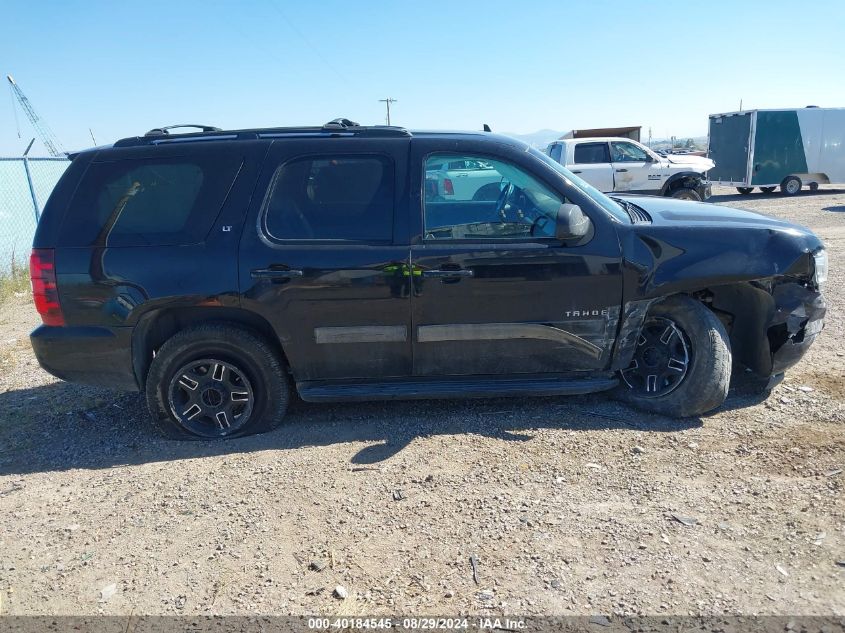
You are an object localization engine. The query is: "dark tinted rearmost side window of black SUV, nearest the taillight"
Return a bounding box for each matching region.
[59,156,241,246]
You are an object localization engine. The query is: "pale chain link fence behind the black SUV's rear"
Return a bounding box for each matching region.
[0,158,70,274]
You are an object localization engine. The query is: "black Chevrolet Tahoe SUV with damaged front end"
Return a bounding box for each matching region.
[31,119,827,438]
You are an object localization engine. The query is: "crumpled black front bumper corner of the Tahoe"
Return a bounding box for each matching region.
[767,283,827,375]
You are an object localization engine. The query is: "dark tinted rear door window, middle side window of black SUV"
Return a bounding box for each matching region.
[265,156,394,242]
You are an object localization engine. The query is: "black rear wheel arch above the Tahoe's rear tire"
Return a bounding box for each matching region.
[132,306,290,389]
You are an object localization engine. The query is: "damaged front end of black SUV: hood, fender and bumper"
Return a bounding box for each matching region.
[613,200,826,377]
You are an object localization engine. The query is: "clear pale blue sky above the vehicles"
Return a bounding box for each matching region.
[0,0,845,155]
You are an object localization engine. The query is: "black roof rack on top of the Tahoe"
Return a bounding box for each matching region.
[114,118,411,147]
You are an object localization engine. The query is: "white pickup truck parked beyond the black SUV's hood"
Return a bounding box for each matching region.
[546,138,715,200]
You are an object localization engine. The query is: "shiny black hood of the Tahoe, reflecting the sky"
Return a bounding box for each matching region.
[618,196,818,239]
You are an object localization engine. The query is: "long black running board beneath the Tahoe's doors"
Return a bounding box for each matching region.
[296,376,619,402]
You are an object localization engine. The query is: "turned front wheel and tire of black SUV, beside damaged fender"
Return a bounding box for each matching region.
[616,295,731,417]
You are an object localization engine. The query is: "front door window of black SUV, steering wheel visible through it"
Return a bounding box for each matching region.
[424,154,566,240]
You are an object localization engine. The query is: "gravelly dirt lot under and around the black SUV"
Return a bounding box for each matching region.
[0,187,845,616]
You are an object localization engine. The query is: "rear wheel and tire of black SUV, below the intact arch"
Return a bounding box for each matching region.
[146,323,290,440]
